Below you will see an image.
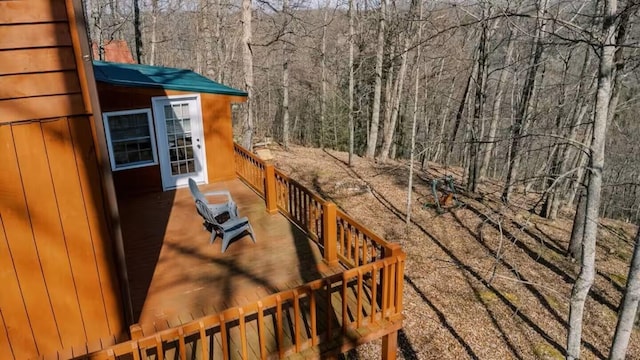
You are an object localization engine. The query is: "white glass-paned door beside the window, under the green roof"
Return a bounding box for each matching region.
[152,95,207,190]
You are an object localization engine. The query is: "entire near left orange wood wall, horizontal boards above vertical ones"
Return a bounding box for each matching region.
[0,0,124,359]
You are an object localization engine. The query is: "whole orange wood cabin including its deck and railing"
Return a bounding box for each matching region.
[0,0,406,359]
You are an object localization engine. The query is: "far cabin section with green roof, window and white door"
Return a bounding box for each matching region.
[93,61,247,195]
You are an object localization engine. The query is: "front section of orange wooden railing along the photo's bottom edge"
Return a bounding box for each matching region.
[79,254,405,359]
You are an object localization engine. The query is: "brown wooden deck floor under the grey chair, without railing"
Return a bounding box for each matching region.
[118,179,344,335]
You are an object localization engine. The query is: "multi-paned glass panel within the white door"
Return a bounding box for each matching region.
[164,103,196,176]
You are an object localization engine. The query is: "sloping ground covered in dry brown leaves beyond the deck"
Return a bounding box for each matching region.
[271,147,640,359]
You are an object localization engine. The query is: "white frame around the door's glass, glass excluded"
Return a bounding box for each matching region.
[151,94,209,191]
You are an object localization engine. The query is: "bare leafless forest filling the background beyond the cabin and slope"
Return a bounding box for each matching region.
[85,0,640,358]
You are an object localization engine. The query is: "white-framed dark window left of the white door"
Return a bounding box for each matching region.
[102,109,158,170]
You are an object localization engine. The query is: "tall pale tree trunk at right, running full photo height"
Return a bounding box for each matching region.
[567,0,617,360]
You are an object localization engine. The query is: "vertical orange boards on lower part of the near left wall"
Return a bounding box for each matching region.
[0,117,123,358]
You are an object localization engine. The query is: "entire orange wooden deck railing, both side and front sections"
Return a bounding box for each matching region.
[77,144,405,359]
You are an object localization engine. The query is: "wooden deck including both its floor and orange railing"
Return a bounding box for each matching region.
[80,145,406,360]
